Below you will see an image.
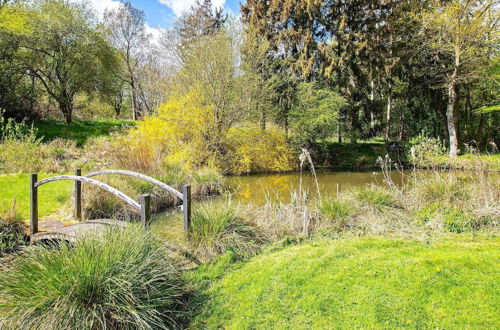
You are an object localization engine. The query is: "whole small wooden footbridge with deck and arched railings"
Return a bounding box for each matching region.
[30,169,191,243]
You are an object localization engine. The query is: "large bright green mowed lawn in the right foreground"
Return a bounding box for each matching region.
[192,236,500,329]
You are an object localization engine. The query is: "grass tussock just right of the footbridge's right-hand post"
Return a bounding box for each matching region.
[189,201,263,259]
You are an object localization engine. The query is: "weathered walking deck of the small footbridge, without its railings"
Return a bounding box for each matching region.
[31,219,128,243]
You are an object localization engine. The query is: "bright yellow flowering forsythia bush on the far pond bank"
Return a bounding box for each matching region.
[115,89,296,174]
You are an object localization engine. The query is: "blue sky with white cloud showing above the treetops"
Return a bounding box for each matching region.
[90,0,244,28]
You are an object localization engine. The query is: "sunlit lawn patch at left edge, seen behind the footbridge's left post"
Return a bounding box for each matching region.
[0,173,73,220]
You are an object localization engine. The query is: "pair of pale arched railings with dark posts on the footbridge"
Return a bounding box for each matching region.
[30,169,191,235]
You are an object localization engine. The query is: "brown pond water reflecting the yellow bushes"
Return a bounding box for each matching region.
[226,171,402,205]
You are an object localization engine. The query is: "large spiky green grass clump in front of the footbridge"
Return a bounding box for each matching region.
[0,226,186,329]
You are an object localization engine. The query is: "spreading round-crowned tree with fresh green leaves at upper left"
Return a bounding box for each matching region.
[2,0,116,123]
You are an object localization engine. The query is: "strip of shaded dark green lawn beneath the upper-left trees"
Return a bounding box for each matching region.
[34,120,135,146]
